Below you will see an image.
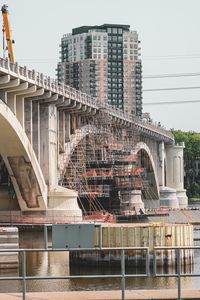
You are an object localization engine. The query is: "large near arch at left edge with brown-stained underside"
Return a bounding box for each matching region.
[0,100,47,210]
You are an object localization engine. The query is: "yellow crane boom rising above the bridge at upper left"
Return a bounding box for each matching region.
[1,4,15,64]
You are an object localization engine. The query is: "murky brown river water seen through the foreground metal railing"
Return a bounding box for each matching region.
[0,226,200,292]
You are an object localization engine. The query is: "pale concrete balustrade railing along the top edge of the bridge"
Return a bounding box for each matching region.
[0,58,174,141]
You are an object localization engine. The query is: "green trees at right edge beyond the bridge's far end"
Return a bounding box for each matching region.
[172,130,200,197]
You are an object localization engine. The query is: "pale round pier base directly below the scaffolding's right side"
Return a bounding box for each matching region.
[120,190,144,215]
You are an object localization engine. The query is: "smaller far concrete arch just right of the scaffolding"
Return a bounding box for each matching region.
[134,142,159,200]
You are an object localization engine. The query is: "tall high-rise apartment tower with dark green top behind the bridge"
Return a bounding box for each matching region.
[57,24,142,116]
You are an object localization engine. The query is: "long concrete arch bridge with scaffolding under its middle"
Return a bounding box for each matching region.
[0,58,187,220]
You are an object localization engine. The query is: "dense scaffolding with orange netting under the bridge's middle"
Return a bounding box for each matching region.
[62,110,154,218]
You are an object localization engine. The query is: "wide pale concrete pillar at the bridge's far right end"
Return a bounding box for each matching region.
[166,143,188,208]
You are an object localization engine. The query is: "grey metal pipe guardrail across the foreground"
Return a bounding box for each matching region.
[0,246,200,300]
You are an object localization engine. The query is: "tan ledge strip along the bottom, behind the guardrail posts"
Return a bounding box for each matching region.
[0,289,200,300]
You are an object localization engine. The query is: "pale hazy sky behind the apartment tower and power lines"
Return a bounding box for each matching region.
[0,0,200,132]
